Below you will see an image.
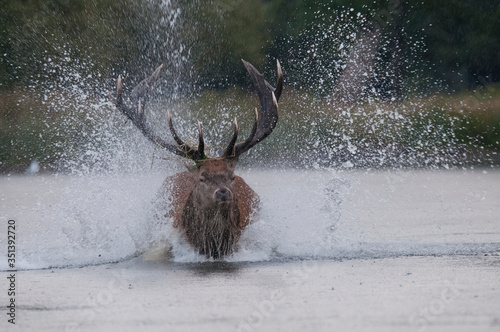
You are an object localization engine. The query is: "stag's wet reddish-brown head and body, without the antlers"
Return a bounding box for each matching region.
[164,159,259,258]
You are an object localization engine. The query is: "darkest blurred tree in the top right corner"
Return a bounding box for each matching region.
[404,0,500,91]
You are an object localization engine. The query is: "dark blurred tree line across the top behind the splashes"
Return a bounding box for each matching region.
[0,0,500,93]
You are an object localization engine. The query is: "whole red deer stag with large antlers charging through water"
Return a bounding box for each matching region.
[116,60,283,259]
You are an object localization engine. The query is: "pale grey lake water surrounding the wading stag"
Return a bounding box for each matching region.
[0,169,500,331]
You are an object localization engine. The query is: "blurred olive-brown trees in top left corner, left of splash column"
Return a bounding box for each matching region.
[0,0,186,88]
